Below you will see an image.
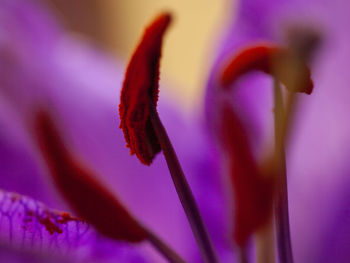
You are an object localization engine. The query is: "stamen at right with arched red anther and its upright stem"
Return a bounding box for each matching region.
[220,41,317,263]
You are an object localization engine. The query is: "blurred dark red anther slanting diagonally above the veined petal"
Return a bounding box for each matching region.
[34,111,147,242]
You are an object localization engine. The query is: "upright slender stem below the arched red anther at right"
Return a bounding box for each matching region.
[274,79,294,263]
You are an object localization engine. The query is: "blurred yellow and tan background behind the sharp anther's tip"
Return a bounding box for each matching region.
[51,0,231,107]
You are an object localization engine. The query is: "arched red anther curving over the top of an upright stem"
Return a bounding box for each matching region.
[220,44,313,94]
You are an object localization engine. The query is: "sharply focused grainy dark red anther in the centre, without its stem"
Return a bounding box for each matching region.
[119,13,171,165]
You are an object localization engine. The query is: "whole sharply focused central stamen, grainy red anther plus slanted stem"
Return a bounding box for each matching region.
[119,14,218,263]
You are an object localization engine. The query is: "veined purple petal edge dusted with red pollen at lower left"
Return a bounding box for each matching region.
[0,191,146,262]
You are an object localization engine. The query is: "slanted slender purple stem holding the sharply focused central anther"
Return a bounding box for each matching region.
[150,103,218,263]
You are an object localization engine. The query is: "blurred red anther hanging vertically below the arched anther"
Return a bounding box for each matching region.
[219,104,273,246]
